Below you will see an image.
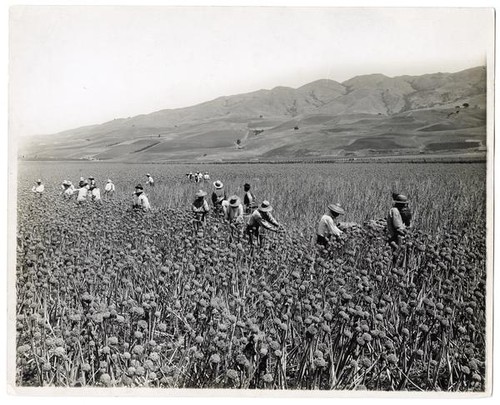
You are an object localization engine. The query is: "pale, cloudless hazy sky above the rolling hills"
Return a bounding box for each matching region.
[9,7,493,136]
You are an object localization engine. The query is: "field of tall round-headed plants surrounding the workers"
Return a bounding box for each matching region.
[16,162,487,391]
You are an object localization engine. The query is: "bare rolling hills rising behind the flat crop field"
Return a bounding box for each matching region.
[19,67,486,162]
